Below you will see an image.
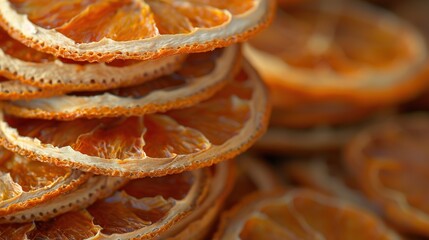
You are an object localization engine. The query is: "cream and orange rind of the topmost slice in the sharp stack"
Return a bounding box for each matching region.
[0,0,276,62]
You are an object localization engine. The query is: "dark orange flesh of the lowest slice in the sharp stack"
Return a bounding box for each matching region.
[0,172,196,239]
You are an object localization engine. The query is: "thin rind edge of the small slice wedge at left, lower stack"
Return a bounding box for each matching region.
[0,170,92,217]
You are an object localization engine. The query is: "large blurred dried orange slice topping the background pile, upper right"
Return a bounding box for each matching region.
[244,1,429,106]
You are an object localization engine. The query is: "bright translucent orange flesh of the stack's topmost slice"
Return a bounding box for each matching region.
[10,0,253,43]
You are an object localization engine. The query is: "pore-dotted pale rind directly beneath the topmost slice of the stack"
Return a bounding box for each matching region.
[0,53,185,92]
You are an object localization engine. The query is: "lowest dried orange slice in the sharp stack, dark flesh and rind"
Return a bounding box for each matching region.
[0,165,215,239]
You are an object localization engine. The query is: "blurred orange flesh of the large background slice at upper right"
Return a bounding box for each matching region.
[250,2,410,76]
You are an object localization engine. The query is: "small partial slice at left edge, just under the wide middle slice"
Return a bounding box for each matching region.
[0,148,91,219]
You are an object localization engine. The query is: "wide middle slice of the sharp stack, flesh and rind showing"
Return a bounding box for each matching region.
[0,61,269,178]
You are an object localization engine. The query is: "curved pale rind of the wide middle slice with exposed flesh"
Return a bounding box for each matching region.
[0,61,271,178]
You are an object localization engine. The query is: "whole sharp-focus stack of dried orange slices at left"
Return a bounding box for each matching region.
[0,0,275,239]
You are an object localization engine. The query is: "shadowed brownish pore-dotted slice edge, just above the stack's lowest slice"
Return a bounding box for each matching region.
[0,176,123,223]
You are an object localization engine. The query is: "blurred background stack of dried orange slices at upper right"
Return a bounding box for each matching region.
[244,0,429,154]
